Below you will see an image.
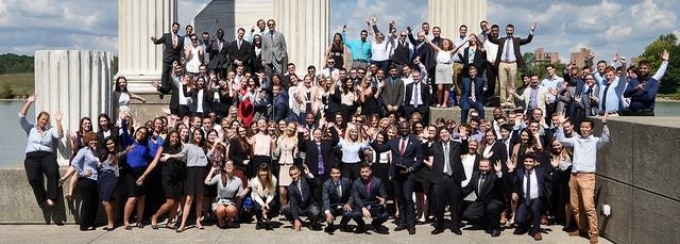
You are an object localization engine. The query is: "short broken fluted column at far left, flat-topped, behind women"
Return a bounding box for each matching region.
[34,50,113,166]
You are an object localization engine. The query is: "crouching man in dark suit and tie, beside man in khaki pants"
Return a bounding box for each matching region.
[508,153,559,241]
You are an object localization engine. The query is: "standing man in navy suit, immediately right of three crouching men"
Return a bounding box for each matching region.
[389,121,423,235]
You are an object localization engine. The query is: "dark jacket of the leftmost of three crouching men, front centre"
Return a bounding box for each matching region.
[288,176,321,221]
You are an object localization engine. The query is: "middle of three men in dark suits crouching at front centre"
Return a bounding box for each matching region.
[323,165,354,233]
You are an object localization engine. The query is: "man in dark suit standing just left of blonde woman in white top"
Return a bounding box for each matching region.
[300,128,339,205]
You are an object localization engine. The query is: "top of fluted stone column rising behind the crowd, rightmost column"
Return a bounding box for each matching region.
[428,0,488,39]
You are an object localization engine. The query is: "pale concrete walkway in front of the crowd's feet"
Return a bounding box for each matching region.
[0,223,612,244]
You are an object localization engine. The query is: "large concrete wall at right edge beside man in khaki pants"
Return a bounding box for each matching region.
[595,117,680,243]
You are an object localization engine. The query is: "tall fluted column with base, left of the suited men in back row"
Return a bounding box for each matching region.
[116,0,177,93]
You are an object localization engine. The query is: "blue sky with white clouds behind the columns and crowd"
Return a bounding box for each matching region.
[0,0,680,61]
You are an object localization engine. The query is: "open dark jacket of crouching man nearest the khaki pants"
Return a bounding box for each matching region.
[508,163,559,200]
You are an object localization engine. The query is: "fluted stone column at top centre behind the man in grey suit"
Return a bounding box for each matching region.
[274,0,330,69]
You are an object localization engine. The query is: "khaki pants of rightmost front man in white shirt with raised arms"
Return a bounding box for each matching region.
[569,173,598,237]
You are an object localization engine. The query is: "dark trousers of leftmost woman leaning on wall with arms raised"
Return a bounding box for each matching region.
[24,152,59,204]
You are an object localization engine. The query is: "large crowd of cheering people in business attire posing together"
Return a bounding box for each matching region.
[19,13,669,243]
